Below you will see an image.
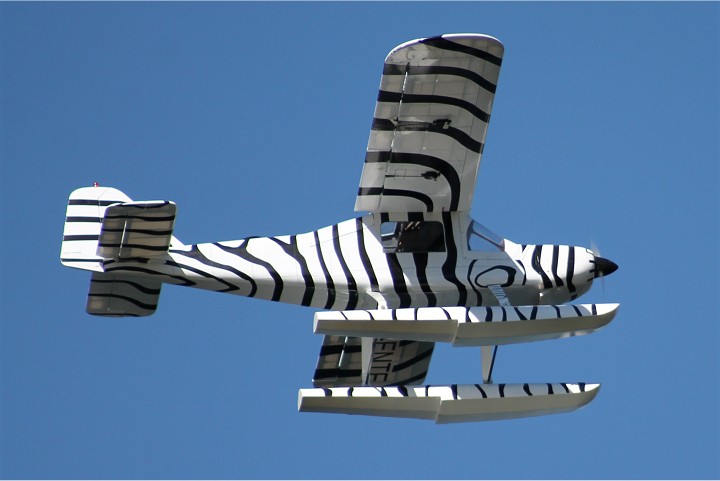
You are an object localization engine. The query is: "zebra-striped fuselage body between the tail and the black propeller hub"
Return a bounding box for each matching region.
[105,212,595,310]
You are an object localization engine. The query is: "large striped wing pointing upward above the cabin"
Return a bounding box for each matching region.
[355,34,503,212]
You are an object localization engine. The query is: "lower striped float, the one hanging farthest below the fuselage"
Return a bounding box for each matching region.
[298,383,600,424]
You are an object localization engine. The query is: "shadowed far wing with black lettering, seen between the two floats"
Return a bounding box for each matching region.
[313,336,435,387]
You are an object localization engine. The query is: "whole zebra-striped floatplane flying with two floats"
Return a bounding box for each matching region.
[60,34,619,423]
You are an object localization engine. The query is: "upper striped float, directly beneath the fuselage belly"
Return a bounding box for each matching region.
[315,304,619,346]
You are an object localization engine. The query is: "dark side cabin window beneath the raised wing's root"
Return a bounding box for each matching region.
[380,221,445,253]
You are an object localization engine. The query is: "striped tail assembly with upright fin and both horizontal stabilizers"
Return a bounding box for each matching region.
[60,187,180,316]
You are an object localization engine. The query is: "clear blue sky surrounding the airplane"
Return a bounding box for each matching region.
[0,2,720,479]
